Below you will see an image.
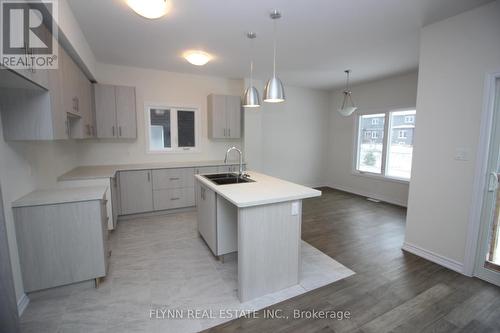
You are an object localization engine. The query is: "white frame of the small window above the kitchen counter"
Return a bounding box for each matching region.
[144,103,201,154]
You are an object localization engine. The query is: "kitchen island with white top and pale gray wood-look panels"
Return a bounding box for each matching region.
[195,171,321,302]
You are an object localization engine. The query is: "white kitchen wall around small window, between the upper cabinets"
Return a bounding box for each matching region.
[75,64,243,165]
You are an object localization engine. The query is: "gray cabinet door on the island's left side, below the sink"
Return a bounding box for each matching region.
[196,182,217,255]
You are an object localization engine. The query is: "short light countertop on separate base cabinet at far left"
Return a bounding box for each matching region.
[12,186,107,207]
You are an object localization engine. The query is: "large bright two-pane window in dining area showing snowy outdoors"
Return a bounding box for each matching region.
[355,110,416,180]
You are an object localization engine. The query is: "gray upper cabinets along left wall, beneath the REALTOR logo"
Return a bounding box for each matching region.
[0,47,94,141]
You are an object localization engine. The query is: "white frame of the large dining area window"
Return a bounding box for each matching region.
[351,106,417,184]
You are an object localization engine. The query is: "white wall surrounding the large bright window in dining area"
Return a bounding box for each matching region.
[326,72,419,206]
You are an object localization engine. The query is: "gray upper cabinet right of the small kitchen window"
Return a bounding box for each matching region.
[207,94,241,139]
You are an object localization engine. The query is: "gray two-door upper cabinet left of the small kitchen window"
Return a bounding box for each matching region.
[93,84,137,139]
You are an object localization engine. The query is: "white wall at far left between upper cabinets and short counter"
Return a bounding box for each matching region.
[0,117,77,300]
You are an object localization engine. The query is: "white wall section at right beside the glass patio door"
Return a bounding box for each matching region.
[406,1,500,265]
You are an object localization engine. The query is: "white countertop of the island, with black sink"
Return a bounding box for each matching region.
[195,171,321,208]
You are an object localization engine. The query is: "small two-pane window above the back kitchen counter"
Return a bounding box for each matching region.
[146,107,198,152]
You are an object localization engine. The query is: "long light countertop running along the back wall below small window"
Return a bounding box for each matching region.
[58,161,244,181]
